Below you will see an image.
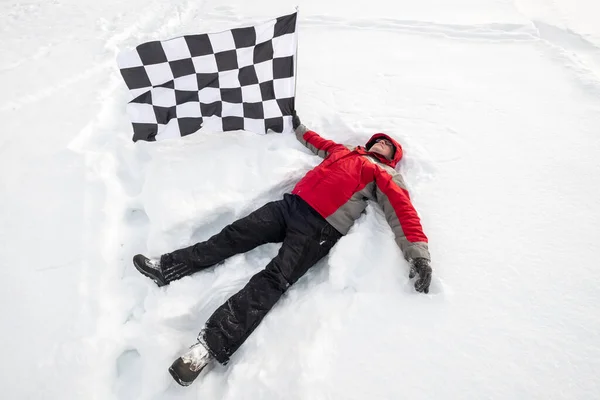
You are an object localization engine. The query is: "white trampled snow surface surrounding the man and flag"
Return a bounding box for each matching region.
[0,0,600,400]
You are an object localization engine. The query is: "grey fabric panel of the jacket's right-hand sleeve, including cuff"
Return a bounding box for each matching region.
[375,177,431,261]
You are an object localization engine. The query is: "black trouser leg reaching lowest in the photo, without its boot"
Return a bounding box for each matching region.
[199,199,342,363]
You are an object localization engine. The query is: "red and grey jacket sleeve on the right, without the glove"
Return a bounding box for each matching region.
[375,164,431,262]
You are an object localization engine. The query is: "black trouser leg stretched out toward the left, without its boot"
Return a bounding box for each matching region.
[160,199,288,282]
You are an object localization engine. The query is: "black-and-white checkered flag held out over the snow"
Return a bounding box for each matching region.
[117,13,297,142]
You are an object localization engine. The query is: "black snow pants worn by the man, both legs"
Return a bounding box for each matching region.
[161,194,342,364]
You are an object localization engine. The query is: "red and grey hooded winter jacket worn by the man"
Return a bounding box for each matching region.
[292,125,430,260]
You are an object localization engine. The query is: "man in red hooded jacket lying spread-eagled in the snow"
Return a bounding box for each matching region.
[133,113,432,386]
